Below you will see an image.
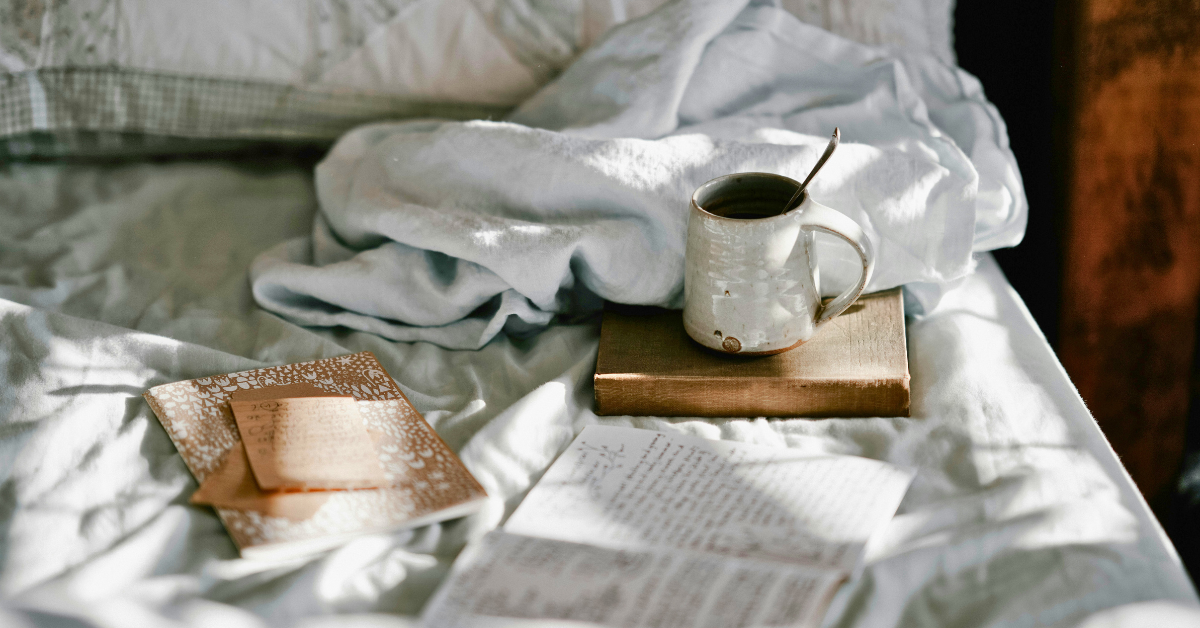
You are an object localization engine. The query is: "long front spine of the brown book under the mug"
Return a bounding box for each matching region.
[595,375,910,417]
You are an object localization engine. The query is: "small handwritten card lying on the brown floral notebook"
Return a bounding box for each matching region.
[230,396,388,490]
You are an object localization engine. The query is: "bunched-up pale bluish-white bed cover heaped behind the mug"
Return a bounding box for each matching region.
[252,0,1026,348]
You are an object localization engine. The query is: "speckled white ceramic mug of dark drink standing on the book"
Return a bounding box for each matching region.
[683,173,875,355]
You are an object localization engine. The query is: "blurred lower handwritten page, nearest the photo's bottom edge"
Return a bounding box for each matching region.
[422,532,844,628]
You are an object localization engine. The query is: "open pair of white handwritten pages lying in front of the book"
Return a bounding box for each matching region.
[424,425,912,627]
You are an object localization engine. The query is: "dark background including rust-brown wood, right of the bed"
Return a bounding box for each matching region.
[955,0,1200,581]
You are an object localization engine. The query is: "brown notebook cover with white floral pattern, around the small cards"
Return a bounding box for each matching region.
[143,352,487,558]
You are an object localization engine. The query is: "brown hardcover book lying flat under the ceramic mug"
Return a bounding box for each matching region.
[595,288,910,417]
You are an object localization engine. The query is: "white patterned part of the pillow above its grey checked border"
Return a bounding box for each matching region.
[0,0,954,108]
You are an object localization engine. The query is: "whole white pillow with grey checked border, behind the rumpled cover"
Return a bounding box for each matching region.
[0,0,953,156]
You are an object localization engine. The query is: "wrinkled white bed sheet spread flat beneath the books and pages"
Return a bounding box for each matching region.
[0,162,1200,628]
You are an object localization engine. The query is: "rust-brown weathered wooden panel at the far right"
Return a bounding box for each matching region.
[1060,0,1200,503]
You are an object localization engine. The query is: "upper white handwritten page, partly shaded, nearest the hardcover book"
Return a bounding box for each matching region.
[504,425,912,570]
